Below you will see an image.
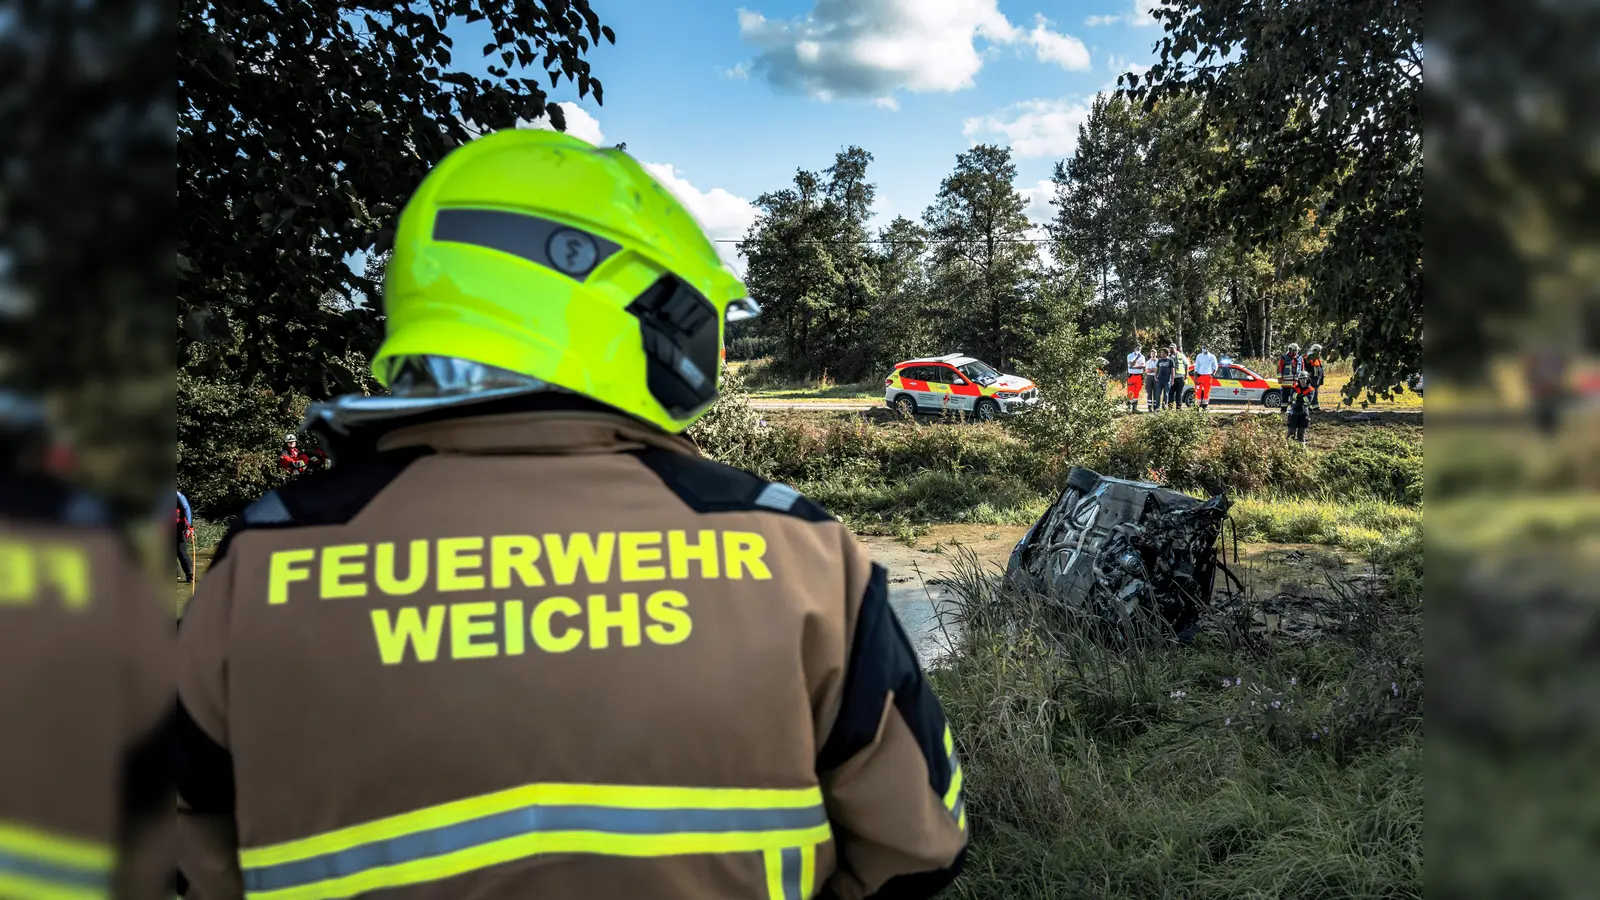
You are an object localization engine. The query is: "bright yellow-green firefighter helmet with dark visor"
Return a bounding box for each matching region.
[373,130,758,432]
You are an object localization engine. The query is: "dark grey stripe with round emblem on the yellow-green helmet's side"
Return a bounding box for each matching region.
[434,210,622,282]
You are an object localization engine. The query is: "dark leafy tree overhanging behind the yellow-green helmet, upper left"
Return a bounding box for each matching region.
[178,0,616,394]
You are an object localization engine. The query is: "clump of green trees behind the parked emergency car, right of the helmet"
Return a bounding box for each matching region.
[739,146,1053,381]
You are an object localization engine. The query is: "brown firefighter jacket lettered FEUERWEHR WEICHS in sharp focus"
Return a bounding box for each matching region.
[179,400,966,900]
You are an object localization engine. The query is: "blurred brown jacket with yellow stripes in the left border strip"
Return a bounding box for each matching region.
[0,391,173,898]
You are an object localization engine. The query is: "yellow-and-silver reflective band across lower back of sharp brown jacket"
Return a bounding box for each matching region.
[238,785,832,900]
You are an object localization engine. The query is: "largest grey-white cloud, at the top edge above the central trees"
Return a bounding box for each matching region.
[739,0,1021,99]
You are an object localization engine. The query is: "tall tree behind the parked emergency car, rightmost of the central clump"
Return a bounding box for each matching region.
[923,144,1040,368]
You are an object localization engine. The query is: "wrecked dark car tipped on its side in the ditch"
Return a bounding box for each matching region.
[1006,466,1230,641]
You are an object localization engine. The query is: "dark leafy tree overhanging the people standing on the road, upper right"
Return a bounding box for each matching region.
[1123,0,1422,392]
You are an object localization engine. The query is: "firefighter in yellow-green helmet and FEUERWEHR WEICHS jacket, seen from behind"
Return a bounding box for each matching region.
[178,130,968,898]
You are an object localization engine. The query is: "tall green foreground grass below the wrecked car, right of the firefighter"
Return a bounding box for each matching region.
[931,534,1422,900]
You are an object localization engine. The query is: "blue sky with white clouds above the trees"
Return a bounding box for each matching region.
[395,0,1162,271]
